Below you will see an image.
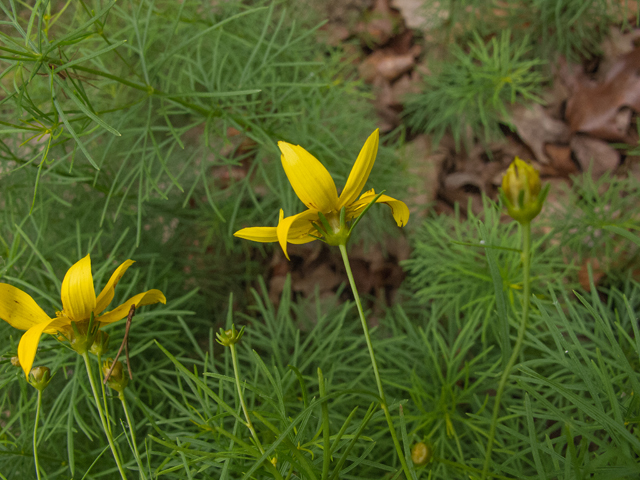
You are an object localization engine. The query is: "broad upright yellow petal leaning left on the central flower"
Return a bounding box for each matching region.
[278,142,338,212]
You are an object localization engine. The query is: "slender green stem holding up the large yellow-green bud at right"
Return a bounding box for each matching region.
[482,222,531,480]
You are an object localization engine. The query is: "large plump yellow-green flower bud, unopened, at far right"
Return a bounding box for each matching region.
[502,157,549,223]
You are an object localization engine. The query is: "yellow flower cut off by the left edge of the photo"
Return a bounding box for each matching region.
[0,255,166,375]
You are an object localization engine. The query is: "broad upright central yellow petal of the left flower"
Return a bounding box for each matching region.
[61,255,96,322]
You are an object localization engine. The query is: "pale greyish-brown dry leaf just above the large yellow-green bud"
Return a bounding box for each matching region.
[511,104,570,164]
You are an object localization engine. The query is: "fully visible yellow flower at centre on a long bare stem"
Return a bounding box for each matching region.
[234,130,409,258]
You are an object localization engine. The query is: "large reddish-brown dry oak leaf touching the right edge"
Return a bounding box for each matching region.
[566,48,640,142]
